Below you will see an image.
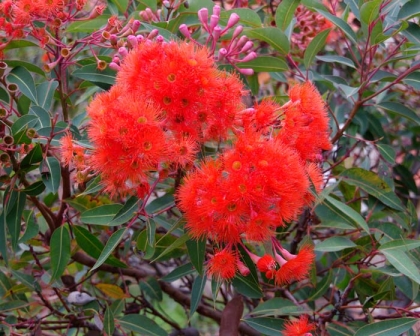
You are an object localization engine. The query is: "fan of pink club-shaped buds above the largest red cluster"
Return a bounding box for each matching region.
[179,5,257,75]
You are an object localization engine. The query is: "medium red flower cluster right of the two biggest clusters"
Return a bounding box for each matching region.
[279,82,332,161]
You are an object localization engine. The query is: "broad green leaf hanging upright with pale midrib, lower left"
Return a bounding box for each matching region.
[50,225,71,282]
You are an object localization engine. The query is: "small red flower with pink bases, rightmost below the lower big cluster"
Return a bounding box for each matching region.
[275,245,315,286]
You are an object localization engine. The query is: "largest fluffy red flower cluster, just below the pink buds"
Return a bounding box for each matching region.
[84,39,242,197]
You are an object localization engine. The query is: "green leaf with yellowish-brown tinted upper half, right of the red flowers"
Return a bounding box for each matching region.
[340,168,404,211]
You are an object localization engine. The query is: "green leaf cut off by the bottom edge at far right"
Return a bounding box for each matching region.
[355,317,418,336]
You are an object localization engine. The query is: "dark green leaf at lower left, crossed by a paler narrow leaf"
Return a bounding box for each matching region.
[72,225,127,268]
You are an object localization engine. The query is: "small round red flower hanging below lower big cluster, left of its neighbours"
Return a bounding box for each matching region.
[207,248,238,280]
